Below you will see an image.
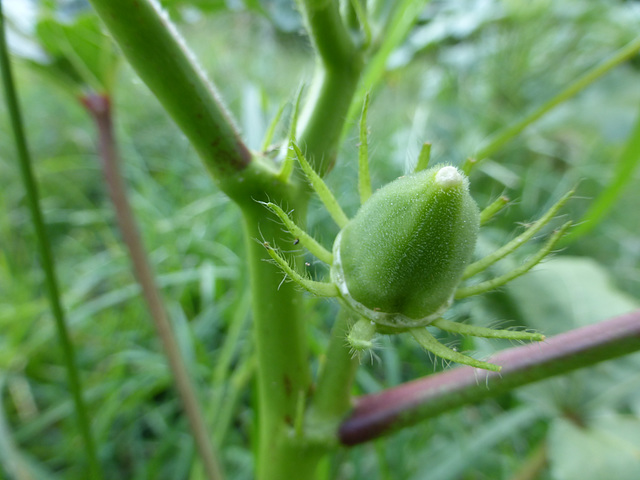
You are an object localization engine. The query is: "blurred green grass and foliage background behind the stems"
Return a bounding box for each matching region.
[0,0,640,480]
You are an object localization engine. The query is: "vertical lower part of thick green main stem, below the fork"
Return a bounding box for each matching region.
[243,204,317,480]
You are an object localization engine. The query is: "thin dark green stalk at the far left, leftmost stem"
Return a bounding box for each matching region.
[0,5,103,480]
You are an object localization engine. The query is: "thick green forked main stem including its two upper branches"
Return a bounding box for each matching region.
[85,0,362,480]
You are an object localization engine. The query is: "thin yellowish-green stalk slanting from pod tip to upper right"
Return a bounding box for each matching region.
[464,33,640,172]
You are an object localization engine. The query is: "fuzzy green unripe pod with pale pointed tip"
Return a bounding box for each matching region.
[331,166,480,329]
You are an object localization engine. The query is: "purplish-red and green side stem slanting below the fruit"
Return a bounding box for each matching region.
[339,310,640,445]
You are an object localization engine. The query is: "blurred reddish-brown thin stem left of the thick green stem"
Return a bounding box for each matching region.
[81,94,223,480]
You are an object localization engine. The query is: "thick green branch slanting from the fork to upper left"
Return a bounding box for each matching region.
[91,0,251,180]
